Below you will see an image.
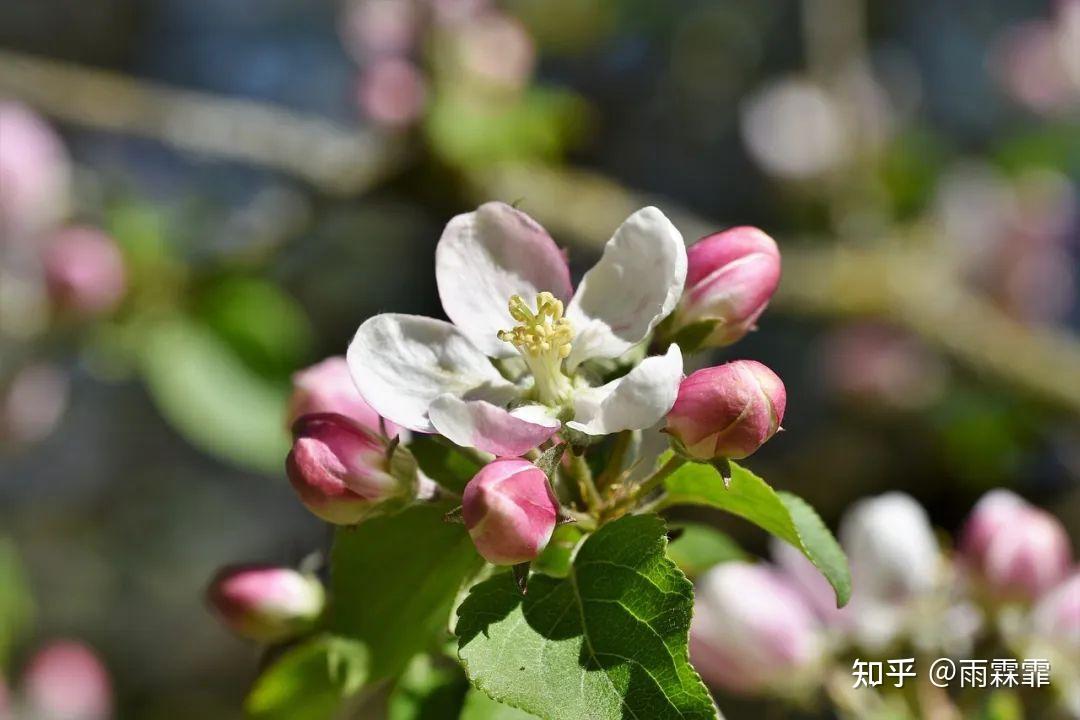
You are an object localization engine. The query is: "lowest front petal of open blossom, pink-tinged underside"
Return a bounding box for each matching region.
[431,395,562,457]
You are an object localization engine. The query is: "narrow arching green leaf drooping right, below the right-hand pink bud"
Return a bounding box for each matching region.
[658,451,851,607]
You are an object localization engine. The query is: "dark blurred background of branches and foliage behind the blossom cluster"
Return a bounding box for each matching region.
[0,0,1080,720]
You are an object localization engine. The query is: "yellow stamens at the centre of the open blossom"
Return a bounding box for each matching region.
[499,293,573,406]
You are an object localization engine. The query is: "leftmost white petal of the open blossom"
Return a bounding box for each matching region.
[348,313,516,433]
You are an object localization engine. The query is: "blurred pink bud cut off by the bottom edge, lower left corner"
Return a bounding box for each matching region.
[23,641,112,720]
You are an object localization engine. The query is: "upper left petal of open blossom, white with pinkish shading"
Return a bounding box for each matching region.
[435,203,573,357]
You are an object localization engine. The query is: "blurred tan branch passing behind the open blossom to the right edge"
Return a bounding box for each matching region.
[474,160,1080,415]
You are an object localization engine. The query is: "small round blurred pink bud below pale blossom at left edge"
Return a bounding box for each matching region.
[43,227,126,316]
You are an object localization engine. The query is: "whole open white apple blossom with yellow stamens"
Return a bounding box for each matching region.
[348,203,687,456]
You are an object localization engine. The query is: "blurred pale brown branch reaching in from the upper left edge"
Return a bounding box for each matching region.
[0,51,403,194]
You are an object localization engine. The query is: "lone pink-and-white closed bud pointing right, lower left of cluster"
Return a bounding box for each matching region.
[206,566,326,642]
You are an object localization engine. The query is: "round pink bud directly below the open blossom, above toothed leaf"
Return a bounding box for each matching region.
[461,458,558,565]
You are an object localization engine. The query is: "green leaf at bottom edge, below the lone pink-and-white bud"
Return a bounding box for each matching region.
[244,635,367,720]
